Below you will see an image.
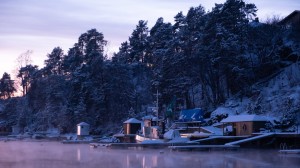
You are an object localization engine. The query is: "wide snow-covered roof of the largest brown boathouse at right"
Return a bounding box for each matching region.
[221,115,269,123]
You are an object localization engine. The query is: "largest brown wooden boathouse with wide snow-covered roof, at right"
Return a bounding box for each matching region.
[221,115,270,136]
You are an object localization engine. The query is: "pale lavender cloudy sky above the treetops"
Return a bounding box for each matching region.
[0,0,300,78]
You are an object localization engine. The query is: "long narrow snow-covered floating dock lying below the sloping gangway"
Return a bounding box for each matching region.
[169,145,240,151]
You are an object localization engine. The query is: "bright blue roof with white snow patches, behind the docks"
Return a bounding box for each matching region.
[179,108,203,122]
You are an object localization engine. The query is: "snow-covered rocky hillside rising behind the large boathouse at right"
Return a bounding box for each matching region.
[211,63,300,129]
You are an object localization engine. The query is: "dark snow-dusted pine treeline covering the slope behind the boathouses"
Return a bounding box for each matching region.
[0,0,299,133]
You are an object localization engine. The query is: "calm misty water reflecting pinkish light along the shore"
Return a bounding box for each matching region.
[0,141,300,168]
